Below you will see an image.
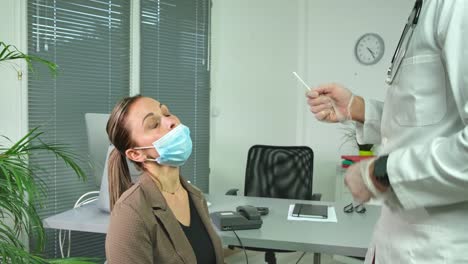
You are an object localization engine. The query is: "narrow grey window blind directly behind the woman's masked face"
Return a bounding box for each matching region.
[140,0,210,192]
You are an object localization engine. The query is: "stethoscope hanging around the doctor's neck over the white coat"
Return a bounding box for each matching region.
[385,0,423,84]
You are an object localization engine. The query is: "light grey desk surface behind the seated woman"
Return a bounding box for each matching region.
[44,195,380,257]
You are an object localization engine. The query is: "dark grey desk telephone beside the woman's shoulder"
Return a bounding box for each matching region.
[211,205,268,231]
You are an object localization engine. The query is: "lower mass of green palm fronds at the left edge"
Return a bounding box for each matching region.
[0,128,87,252]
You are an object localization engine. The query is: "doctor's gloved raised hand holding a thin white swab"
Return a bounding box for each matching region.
[293,72,358,123]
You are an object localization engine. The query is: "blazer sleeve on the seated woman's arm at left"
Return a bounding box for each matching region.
[106,204,155,264]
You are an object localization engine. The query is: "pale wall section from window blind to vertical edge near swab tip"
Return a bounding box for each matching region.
[210,0,299,192]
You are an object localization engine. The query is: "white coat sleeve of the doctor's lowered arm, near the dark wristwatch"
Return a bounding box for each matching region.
[387,0,468,209]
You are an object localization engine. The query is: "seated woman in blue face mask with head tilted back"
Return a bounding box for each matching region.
[106,96,223,264]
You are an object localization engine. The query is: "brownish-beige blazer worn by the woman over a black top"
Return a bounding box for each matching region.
[106,174,223,264]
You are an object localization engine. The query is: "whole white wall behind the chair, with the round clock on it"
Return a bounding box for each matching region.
[210,0,412,200]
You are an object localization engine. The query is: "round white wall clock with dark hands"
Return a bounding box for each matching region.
[354,33,385,65]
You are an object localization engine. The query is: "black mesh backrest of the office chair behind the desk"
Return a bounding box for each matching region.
[244,145,314,200]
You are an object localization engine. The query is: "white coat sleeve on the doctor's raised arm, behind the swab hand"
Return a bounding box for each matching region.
[356,99,383,144]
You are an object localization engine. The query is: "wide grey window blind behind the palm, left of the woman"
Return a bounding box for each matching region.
[28,0,130,258]
